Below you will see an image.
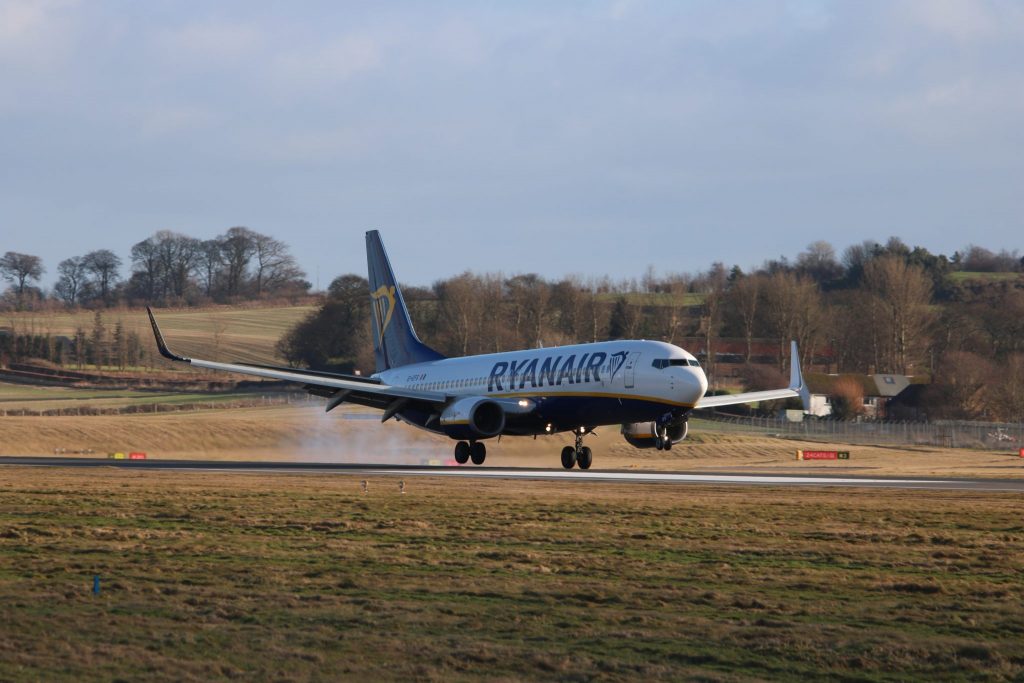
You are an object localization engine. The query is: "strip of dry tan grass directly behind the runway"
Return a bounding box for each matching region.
[0,399,1024,478]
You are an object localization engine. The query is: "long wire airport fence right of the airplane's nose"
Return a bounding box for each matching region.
[695,413,1024,452]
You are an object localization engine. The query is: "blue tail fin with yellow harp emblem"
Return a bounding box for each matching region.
[367,230,444,372]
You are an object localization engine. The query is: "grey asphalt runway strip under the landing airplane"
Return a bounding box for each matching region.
[0,456,1024,493]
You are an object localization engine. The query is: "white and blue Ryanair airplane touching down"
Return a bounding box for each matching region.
[146,230,810,470]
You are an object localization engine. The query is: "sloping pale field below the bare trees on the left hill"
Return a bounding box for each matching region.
[0,305,315,367]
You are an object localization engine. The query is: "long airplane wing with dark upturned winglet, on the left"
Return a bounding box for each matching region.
[145,306,447,422]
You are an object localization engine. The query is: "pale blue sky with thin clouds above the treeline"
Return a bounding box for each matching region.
[0,0,1024,287]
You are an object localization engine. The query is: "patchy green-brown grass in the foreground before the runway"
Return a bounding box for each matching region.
[0,468,1024,681]
